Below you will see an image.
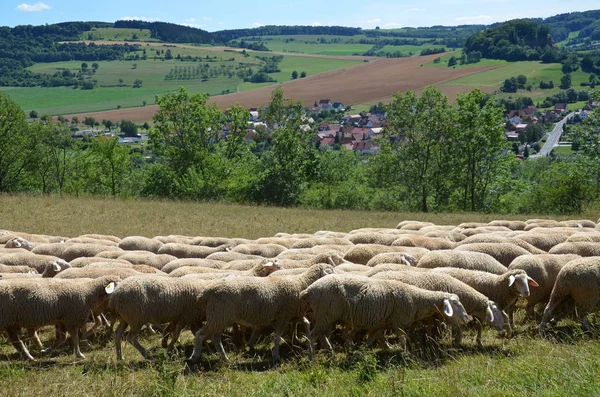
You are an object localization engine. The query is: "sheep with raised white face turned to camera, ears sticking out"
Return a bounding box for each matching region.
[433,267,538,338]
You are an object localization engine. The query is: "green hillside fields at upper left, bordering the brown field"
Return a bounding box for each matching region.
[2,46,362,115]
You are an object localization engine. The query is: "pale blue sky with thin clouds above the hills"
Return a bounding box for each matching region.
[0,0,600,31]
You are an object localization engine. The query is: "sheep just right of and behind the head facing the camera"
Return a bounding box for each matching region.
[507,254,580,327]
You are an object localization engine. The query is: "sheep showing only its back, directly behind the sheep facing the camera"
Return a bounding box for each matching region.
[417,250,508,274]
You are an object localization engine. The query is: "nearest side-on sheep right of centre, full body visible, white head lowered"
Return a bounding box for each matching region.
[300,274,468,360]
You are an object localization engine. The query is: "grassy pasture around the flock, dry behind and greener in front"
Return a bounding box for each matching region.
[0,196,600,396]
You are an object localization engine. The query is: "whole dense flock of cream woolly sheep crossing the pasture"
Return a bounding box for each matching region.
[0,219,600,362]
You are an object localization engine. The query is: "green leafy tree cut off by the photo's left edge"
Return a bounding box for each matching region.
[0,91,37,193]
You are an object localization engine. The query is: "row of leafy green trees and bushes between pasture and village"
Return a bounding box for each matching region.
[0,87,600,213]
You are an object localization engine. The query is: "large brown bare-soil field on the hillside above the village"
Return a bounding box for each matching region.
[66,55,493,123]
